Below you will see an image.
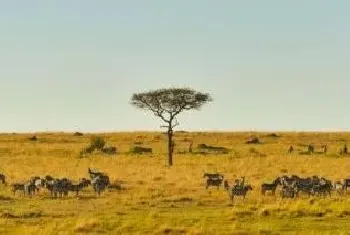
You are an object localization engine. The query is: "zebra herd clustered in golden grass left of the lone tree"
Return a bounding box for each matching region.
[0,168,110,198]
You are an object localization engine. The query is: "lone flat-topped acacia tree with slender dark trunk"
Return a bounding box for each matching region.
[131,88,213,166]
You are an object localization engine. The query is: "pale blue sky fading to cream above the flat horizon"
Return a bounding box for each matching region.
[0,0,350,132]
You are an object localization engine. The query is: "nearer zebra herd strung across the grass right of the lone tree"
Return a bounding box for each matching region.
[203,173,350,201]
